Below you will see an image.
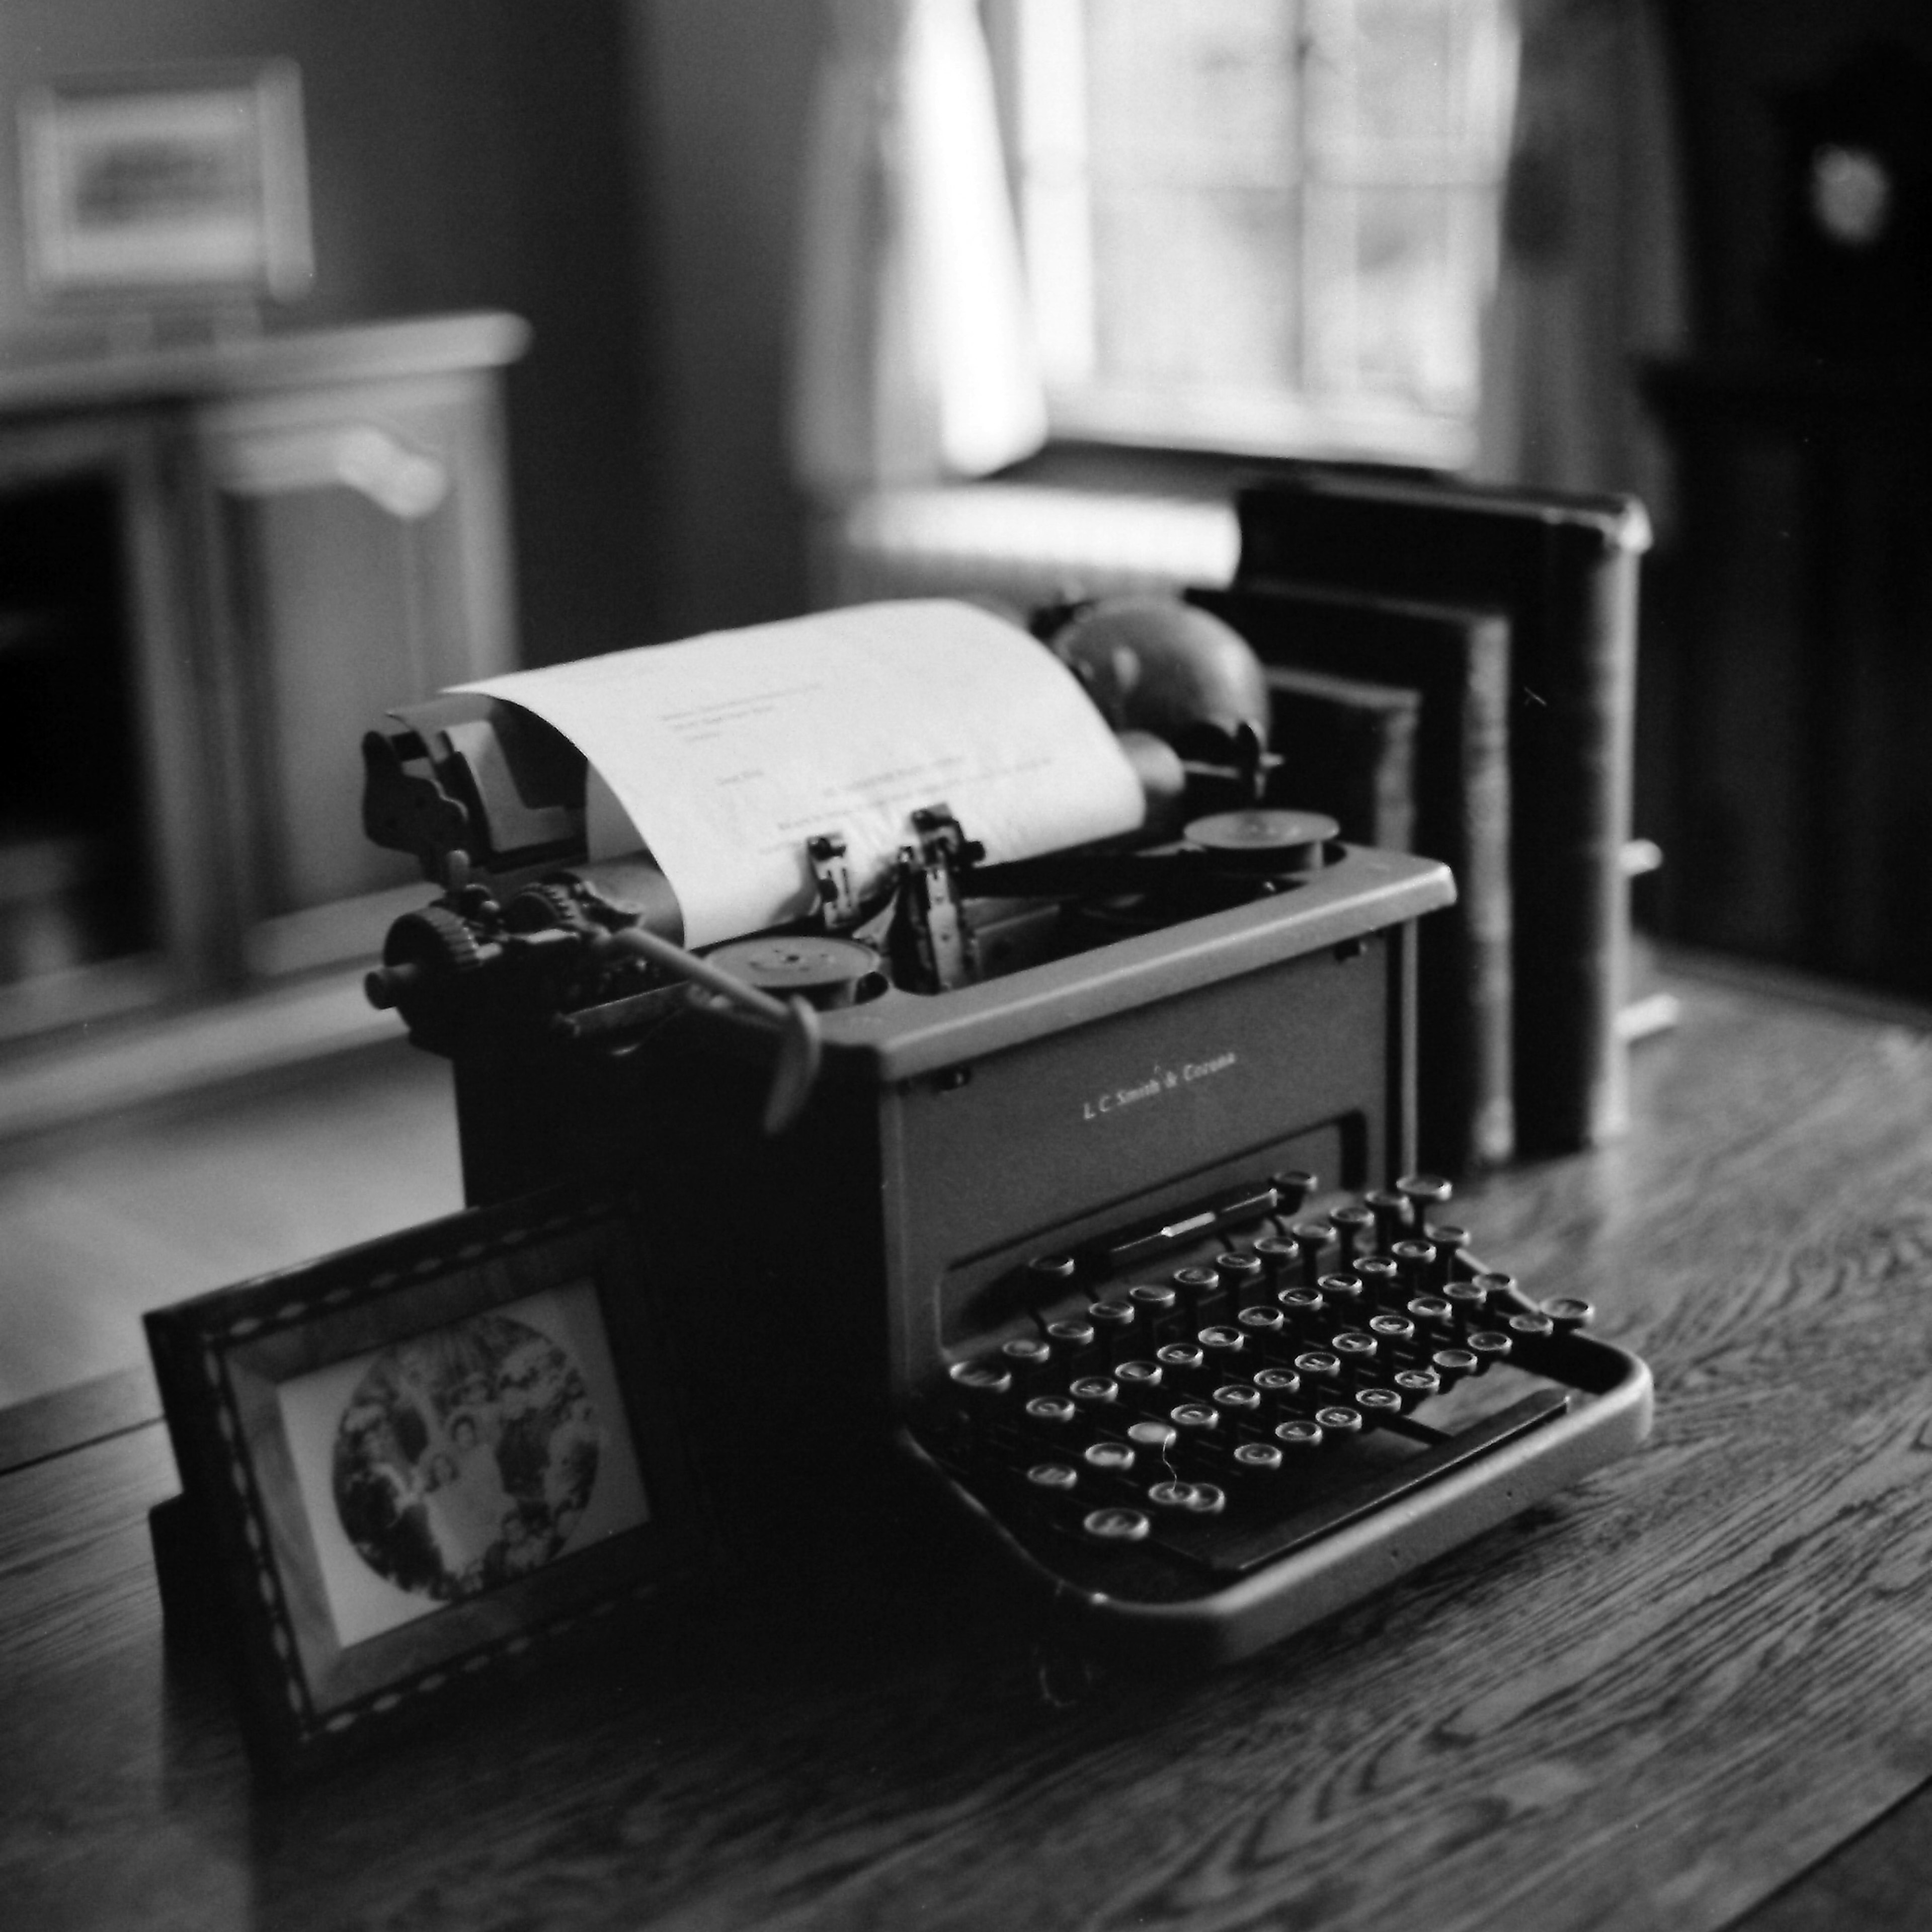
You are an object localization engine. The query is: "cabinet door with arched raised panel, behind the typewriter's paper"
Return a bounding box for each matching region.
[207,375,514,972]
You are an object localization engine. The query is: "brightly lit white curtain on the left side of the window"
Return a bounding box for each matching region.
[792,0,1047,499]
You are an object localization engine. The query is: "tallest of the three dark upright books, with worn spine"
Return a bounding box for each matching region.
[1235,467,1650,1153]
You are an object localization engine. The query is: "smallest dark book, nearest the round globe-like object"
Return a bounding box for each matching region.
[1267,665,1422,852]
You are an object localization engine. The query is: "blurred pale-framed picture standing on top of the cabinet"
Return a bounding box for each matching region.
[19,62,313,301]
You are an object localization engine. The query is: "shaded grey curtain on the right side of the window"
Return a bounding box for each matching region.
[1478,0,1686,524]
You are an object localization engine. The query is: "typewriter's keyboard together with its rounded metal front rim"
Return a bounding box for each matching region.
[900,1177,1650,1663]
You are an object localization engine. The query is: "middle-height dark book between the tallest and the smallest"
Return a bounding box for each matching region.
[1188,584,1515,1175]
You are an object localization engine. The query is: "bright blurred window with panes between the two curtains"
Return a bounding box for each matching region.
[997,0,1515,467]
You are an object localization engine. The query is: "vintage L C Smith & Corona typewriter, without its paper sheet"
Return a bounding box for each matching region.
[365,607,1650,1660]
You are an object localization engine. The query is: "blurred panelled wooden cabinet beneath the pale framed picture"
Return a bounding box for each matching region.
[0,313,527,1039]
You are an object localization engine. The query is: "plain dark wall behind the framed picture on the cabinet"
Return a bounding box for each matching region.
[0,0,657,661]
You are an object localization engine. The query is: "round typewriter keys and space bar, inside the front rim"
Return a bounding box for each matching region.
[920,1175,1590,1600]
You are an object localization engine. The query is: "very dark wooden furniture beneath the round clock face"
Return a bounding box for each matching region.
[1640,350,1932,999]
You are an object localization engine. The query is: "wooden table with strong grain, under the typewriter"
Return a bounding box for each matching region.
[0,980,1932,1932]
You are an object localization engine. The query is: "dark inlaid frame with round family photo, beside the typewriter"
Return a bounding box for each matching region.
[147,1196,707,1774]
